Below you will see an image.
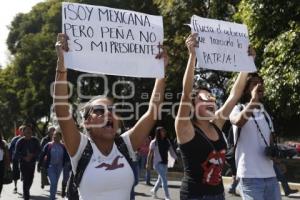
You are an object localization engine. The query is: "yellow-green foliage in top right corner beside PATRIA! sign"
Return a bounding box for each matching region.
[235,0,300,67]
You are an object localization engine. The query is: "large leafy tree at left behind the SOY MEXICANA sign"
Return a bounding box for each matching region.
[0,0,158,138]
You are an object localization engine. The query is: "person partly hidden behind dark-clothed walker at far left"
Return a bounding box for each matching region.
[9,125,26,193]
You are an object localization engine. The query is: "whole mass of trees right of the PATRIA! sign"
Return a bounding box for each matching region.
[235,0,300,134]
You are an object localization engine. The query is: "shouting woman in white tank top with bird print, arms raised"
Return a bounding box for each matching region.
[54,34,168,200]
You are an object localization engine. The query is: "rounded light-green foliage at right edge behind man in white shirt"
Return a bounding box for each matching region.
[261,24,300,132]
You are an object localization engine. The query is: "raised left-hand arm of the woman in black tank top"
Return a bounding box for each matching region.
[175,33,197,144]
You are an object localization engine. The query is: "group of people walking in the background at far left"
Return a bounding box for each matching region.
[0,124,71,200]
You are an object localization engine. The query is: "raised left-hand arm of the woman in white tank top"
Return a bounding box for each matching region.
[53,33,80,156]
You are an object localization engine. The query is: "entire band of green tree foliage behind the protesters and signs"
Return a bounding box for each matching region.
[0,0,300,138]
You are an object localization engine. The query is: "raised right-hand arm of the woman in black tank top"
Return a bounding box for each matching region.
[213,47,256,130]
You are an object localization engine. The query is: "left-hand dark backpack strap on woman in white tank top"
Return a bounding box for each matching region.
[72,140,93,188]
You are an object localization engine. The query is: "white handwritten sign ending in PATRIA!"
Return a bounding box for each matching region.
[191,15,256,72]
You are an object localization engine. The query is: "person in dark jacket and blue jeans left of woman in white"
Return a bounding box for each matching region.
[38,129,68,200]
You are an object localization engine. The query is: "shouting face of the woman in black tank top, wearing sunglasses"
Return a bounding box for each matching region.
[194,90,217,119]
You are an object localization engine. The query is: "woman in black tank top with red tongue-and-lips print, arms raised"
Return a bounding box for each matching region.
[175,34,254,200]
